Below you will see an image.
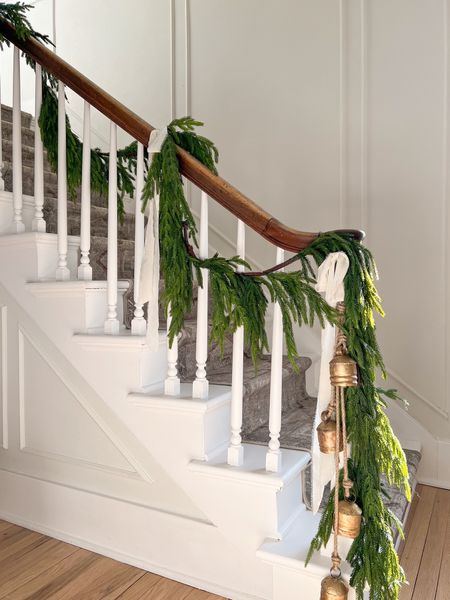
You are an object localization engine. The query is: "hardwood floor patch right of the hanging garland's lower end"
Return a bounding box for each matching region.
[400,485,450,600]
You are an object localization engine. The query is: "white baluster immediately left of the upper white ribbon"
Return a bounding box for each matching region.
[131,142,146,335]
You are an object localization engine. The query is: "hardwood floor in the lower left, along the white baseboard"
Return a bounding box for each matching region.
[0,521,225,600]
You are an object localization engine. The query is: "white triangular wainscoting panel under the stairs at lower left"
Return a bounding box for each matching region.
[0,290,165,506]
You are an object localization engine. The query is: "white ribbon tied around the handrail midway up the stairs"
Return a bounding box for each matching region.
[137,129,167,350]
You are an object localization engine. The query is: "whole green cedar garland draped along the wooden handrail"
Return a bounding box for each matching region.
[0,2,411,600]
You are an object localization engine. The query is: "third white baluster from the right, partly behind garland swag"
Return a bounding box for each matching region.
[192,192,209,398]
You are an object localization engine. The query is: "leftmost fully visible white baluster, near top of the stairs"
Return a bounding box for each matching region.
[12,46,25,233]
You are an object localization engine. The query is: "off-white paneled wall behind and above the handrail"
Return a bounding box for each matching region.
[18,0,450,439]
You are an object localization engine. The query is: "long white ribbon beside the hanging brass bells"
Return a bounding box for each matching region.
[311,252,349,513]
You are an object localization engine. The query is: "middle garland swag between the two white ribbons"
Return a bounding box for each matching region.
[143,117,336,367]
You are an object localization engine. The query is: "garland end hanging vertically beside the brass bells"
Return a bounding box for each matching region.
[303,233,411,600]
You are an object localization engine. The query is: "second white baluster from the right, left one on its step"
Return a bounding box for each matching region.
[228,221,245,467]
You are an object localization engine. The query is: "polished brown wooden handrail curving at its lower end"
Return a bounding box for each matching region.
[0,19,364,252]
